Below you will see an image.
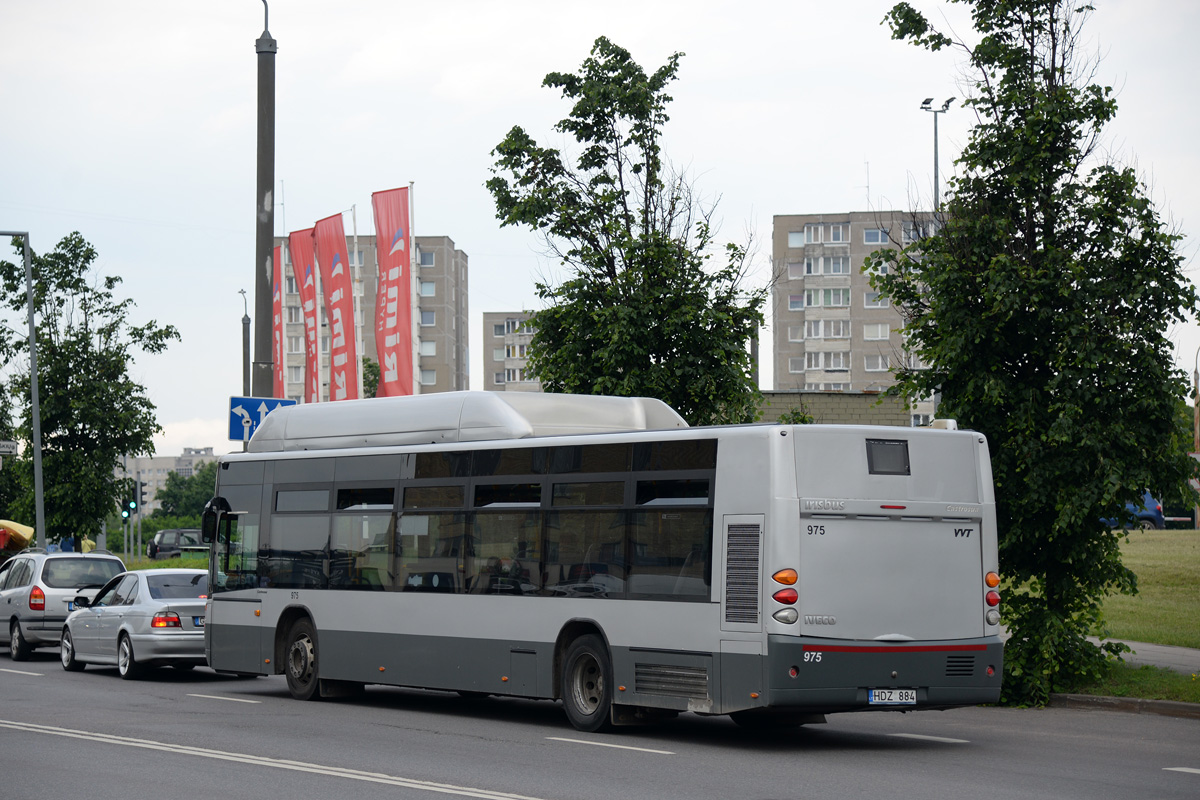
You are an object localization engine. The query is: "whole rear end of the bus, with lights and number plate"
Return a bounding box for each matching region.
[763,426,1003,712]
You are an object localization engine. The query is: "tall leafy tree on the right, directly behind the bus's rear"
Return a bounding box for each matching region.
[868,0,1196,704]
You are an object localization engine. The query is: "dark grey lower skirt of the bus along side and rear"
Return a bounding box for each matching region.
[210,625,1003,714]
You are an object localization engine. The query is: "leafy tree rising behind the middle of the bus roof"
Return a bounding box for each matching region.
[487,37,767,425]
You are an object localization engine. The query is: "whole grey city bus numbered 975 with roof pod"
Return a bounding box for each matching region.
[203,391,1003,730]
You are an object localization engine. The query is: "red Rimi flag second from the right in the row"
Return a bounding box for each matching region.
[312,213,359,401]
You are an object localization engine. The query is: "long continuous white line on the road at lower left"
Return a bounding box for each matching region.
[0,720,552,800]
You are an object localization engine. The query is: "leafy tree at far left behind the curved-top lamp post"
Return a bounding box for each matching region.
[0,233,179,541]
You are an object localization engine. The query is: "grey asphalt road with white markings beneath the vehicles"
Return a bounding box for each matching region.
[0,651,1200,800]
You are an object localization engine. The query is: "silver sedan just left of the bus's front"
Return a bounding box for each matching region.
[60,570,209,679]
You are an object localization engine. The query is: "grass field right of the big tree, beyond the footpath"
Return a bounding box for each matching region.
[1104,530,1200,652]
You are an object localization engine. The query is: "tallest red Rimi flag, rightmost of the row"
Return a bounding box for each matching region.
[371,188,413,397]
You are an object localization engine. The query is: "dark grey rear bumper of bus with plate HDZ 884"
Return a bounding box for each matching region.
[766,636,1004,714]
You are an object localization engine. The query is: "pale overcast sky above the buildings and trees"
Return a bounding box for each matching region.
[0,0,1200,456]
